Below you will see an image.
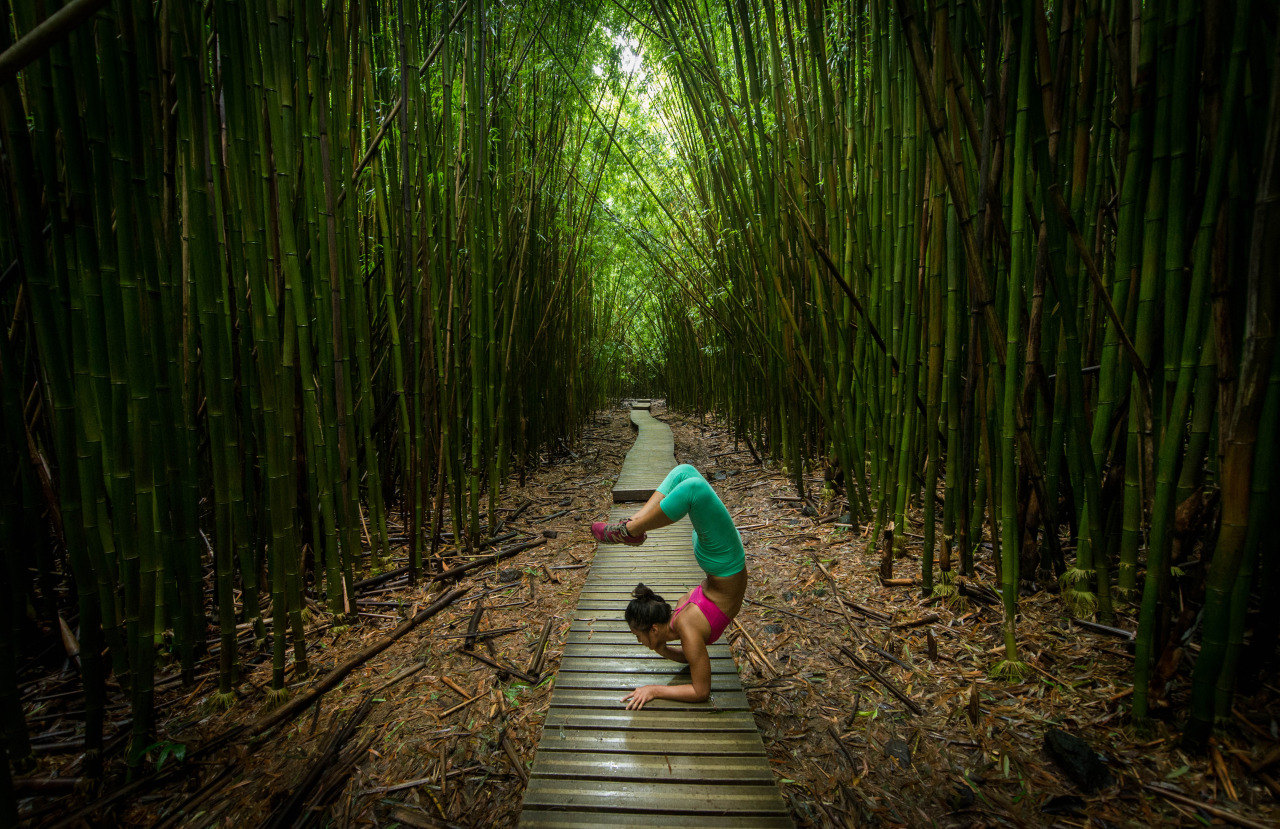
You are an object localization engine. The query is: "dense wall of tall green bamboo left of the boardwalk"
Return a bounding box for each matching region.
[0,0,640,774]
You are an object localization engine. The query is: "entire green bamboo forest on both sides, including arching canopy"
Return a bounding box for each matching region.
[0,0,1280,800]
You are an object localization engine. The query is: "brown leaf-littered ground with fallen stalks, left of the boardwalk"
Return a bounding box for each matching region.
[22,409,631,825]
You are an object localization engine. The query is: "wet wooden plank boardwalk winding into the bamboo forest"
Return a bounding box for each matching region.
[520,407,792,826]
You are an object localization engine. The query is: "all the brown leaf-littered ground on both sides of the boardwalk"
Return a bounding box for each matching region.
[12,407,1280,826]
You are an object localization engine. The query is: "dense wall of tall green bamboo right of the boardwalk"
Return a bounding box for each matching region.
[632,0,1280,745]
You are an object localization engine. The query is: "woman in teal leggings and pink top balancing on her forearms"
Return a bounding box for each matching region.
[591,463,746,709]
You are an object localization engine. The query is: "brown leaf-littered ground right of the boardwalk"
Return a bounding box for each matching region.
[655,407,1280,826]
